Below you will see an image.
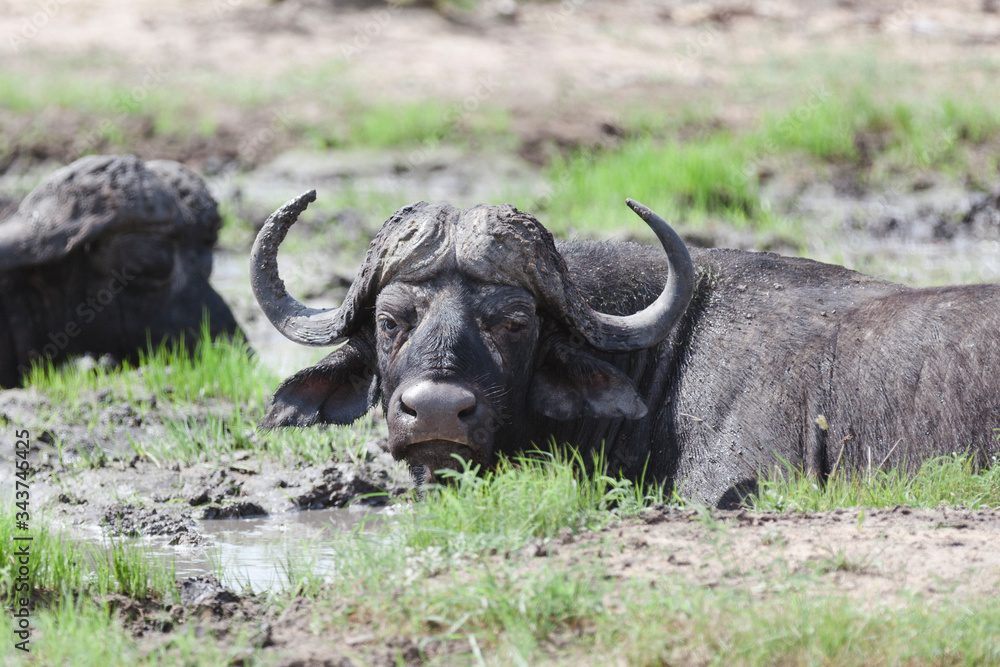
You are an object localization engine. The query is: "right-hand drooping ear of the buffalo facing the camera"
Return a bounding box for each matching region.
[528,346,646,419]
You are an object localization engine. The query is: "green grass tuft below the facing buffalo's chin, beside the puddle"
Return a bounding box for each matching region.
[306,452,663,586]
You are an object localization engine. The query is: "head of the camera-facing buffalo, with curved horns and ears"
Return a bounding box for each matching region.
[251,192,694,480]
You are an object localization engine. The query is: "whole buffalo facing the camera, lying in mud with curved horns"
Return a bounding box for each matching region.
[251,193,1000,505]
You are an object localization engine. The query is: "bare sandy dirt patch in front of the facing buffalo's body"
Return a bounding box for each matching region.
[580,507,1000,604]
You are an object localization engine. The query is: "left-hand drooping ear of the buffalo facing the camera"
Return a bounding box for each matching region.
[260,339,379,429]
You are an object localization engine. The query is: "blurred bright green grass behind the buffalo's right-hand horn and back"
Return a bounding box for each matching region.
[540,89,1000,242]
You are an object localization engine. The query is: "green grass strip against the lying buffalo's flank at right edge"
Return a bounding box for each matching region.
[747,454,1000,512]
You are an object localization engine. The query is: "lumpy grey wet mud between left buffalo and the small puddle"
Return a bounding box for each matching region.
[0,380,412,546]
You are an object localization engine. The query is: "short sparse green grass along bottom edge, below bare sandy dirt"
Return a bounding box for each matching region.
[352,563,1000,666]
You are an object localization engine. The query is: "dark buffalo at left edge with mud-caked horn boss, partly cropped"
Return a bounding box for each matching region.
[0,156,237,387]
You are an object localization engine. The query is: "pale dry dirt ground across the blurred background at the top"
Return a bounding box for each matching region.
[0,0,1000,166]
